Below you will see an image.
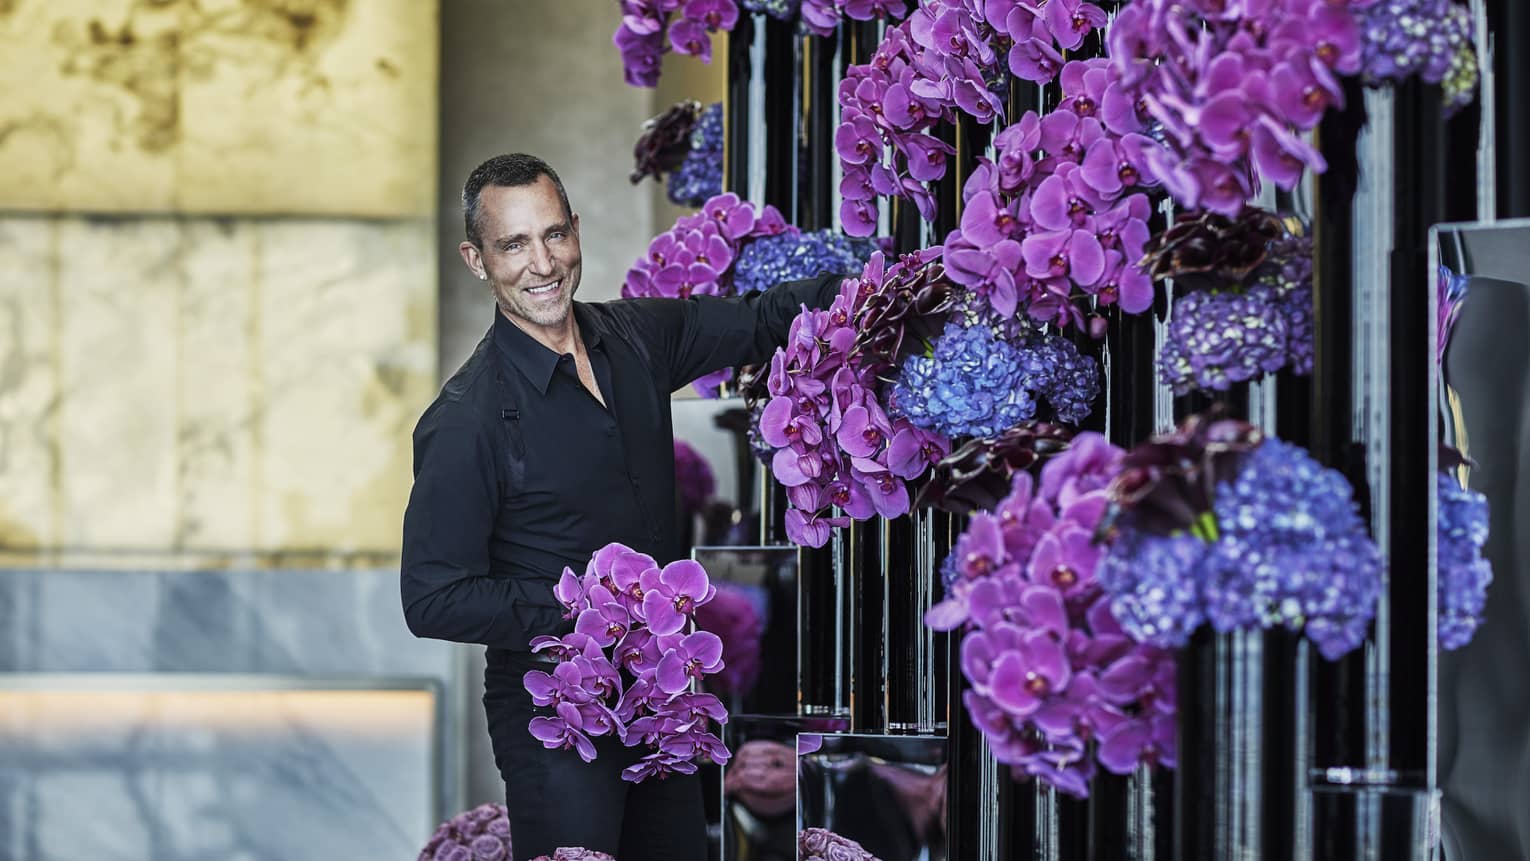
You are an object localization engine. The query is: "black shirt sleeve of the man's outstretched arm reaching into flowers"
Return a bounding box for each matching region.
[635,275,845,388]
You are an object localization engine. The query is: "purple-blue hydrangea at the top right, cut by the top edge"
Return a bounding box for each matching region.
[1351,0,1478,116]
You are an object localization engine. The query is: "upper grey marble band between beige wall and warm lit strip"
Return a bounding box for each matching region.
[0,570,453,677]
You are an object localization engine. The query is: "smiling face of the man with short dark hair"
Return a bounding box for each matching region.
[464,176,583,329]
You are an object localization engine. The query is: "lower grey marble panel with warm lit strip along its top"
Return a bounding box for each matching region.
[0,676,441,861]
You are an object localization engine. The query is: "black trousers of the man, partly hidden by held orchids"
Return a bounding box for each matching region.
[483,650,707,861]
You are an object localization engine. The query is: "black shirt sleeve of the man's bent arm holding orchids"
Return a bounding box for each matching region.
[399,411,566,650]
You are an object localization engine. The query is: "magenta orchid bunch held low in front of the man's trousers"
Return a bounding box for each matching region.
[525,543,728,783]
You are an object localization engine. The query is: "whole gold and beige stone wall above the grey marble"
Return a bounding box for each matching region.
[0,0,439,567]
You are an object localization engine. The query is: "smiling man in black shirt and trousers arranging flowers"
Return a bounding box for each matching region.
[402,154,838,861]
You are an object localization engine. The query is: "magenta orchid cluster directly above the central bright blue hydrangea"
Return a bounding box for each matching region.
[946,58,1155,326]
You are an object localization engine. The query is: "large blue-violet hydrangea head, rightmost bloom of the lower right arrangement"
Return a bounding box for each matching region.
[1206,439,1382,661]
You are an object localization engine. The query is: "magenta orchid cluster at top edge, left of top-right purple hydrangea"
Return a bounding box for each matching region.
[1106,0,1375,216]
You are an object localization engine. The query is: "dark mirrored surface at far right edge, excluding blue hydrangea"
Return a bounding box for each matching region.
[1440,270,1530,861]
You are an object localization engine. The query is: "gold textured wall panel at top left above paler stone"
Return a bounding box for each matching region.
[0,0,439,217]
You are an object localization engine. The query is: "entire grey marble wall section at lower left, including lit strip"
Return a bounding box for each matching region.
[0,569,464,861]
